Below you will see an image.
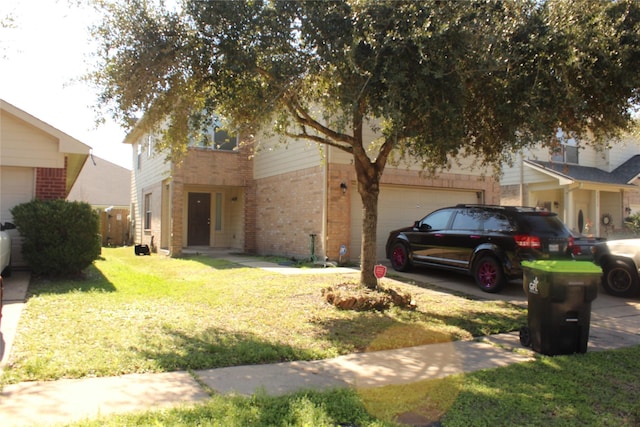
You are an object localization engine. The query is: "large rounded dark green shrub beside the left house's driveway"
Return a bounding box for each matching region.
[11,200,100,276]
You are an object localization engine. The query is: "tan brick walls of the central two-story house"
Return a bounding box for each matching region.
[134,135,499,261]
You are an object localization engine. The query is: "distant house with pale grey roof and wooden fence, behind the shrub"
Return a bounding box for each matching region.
[67,155,131,246]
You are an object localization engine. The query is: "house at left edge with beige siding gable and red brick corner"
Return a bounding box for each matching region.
[0,100,90,267]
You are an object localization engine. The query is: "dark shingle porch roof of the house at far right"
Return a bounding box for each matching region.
[525,159,640,185]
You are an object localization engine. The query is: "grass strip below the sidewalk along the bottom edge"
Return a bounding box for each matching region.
[58,346,640,427]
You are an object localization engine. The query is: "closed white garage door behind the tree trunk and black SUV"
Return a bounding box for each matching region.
[349,185,478,261]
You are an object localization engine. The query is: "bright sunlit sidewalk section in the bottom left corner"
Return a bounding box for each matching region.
[0,372,209,427]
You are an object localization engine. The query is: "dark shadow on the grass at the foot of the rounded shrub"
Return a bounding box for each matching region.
[27,265,116,298]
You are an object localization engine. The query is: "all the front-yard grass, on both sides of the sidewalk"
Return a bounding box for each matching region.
[3,248,640,427]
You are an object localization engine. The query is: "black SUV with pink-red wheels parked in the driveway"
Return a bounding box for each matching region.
[386,205,573,292]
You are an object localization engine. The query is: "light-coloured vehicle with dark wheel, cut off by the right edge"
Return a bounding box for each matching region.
[594,239,640,297]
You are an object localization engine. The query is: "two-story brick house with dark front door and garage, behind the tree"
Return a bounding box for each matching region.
[125,118,499,262]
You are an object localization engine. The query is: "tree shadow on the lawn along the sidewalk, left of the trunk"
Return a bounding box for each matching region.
[138,327,324,371]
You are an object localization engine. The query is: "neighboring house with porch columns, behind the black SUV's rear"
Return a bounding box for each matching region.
[501,137,640,238]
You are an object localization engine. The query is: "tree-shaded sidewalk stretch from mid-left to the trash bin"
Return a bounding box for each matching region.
[195,334,534,395]
